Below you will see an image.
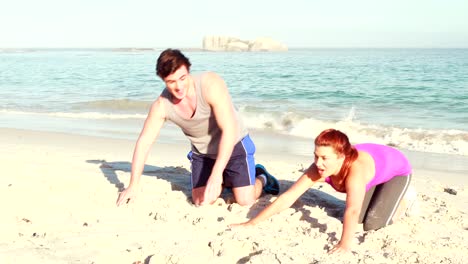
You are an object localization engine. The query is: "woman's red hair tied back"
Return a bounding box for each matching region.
[315,129,358,181]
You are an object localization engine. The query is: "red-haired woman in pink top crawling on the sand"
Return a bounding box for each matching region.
[231,129,411,253]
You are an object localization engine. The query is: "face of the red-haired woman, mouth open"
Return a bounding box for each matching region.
[314,146,345,177]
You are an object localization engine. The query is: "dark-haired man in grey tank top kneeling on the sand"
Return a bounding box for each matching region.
[117,49,279,206]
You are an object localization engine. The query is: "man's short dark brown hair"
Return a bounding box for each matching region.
[156,49,192,79]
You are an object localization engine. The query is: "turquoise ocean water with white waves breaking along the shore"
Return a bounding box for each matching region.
[0,49,468,156]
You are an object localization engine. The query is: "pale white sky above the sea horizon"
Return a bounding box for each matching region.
[0,0,468,48]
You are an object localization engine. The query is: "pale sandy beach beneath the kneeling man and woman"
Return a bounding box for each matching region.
[0,128,468,264]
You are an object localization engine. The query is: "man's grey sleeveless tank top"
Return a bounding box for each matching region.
[161,72,248,158]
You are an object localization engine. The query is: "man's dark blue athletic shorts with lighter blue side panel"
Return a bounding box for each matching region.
[187,135,255,189]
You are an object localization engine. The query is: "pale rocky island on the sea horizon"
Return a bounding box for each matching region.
[203,36,288,52]
